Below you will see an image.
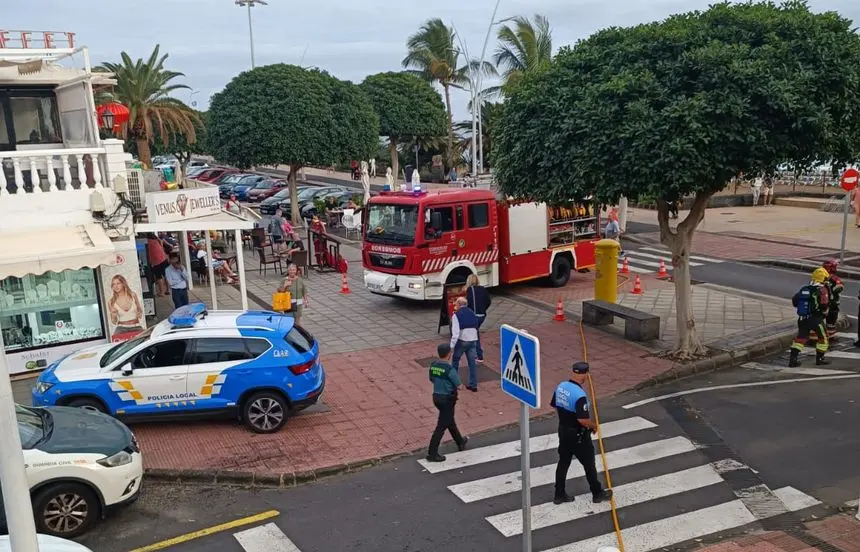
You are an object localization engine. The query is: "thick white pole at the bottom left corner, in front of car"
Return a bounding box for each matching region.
[0,334,39,552]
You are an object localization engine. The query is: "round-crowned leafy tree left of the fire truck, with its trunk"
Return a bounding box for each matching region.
[208,64,379,223]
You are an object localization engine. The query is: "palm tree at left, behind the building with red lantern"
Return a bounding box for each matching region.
[96,45,199,167]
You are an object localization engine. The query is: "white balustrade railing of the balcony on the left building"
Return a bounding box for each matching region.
[0,148,105,196]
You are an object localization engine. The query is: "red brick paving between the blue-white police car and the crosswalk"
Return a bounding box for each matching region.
[129,322,671,474]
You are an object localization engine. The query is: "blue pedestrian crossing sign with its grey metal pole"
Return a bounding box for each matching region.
[499,324,540,552]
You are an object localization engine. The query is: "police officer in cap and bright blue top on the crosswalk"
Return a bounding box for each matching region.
[550,362,612,504]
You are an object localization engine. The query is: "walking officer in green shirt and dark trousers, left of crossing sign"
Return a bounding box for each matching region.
[427,343,469,462]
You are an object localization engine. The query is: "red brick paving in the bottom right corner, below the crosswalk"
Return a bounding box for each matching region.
[696,514,860,552]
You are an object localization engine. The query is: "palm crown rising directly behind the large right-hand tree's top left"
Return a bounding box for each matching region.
[493,15,552,92]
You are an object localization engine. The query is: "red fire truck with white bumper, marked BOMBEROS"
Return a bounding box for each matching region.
[362,189,600,300]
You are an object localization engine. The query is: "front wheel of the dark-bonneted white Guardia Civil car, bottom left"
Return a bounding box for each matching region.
[33,483,99,539]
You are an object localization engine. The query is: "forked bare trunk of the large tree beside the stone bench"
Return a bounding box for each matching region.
[657,194,711,360]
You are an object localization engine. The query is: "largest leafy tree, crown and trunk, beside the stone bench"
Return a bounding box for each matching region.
[494,1,860,358]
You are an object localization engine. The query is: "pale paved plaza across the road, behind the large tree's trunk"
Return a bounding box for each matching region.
[629,205,848,254]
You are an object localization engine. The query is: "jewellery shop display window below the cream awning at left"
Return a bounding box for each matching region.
[0,269,105,352]
